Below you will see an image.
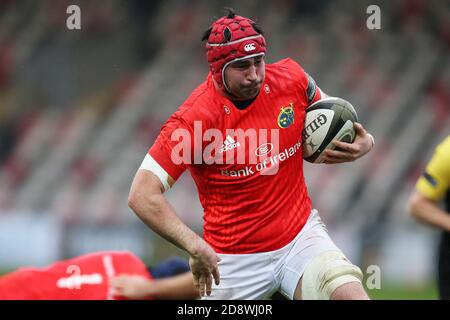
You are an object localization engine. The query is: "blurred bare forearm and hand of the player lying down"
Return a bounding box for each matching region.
[109,272,198,300]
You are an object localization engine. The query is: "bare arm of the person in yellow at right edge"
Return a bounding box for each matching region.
[408,190,450,231]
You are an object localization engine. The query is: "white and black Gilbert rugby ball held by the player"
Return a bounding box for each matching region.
[302,97,358,163]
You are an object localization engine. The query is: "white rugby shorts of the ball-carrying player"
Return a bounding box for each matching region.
[202,209,340,300]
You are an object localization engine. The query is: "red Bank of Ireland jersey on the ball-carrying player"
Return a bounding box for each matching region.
[148,58,321,253]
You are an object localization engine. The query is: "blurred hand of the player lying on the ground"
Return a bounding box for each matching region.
[109,274,150,300]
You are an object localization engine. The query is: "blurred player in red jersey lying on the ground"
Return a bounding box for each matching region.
[0,251,198,300]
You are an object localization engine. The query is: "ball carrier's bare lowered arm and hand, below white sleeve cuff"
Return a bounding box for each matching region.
[128,170,220,296]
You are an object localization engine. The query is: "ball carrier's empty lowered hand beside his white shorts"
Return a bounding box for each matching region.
[189,241,220,297]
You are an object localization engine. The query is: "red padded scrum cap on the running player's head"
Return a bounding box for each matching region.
[203,10,266,89]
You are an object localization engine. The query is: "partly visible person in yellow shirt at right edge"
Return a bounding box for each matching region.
[409,136,450,300]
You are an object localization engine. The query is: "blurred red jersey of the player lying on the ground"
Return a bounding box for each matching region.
[0,251,151,300]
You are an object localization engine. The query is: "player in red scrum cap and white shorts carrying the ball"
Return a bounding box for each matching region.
[129,9,374,299]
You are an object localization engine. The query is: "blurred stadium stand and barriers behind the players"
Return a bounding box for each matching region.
[0,0,450,298]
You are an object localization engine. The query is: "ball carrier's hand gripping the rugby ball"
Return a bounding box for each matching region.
[324,122,374,164]
